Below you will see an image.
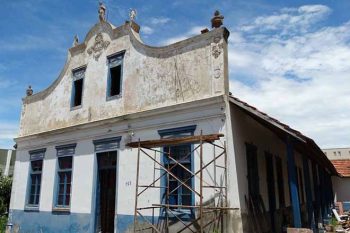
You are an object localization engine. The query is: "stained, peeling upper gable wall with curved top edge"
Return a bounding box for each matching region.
[19,22,228,137]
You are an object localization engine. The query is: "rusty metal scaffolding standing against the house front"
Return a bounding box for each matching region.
[127,134,232,233]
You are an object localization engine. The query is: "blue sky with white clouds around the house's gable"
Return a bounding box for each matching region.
[0,0,350,148]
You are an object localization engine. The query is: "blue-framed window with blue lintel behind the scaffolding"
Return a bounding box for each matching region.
[158,125,196,209]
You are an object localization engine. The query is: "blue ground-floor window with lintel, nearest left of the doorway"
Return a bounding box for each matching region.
[56,144,76,208]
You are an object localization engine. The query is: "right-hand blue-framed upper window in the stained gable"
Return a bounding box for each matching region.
[107,51,124,100]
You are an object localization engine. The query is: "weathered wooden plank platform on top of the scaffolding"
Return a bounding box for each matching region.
[126,134,224,148]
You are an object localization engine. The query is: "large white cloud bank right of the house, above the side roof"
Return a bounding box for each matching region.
[229,5,350,147]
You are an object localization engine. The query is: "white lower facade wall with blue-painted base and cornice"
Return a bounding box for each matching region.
[10,97,230,232]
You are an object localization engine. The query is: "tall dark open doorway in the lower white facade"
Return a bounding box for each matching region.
[96,151,117,233]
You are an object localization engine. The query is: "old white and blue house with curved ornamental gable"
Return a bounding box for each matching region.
[9,5,337,233]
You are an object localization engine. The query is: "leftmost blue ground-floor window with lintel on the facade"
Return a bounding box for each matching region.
[28,149,46,207]
